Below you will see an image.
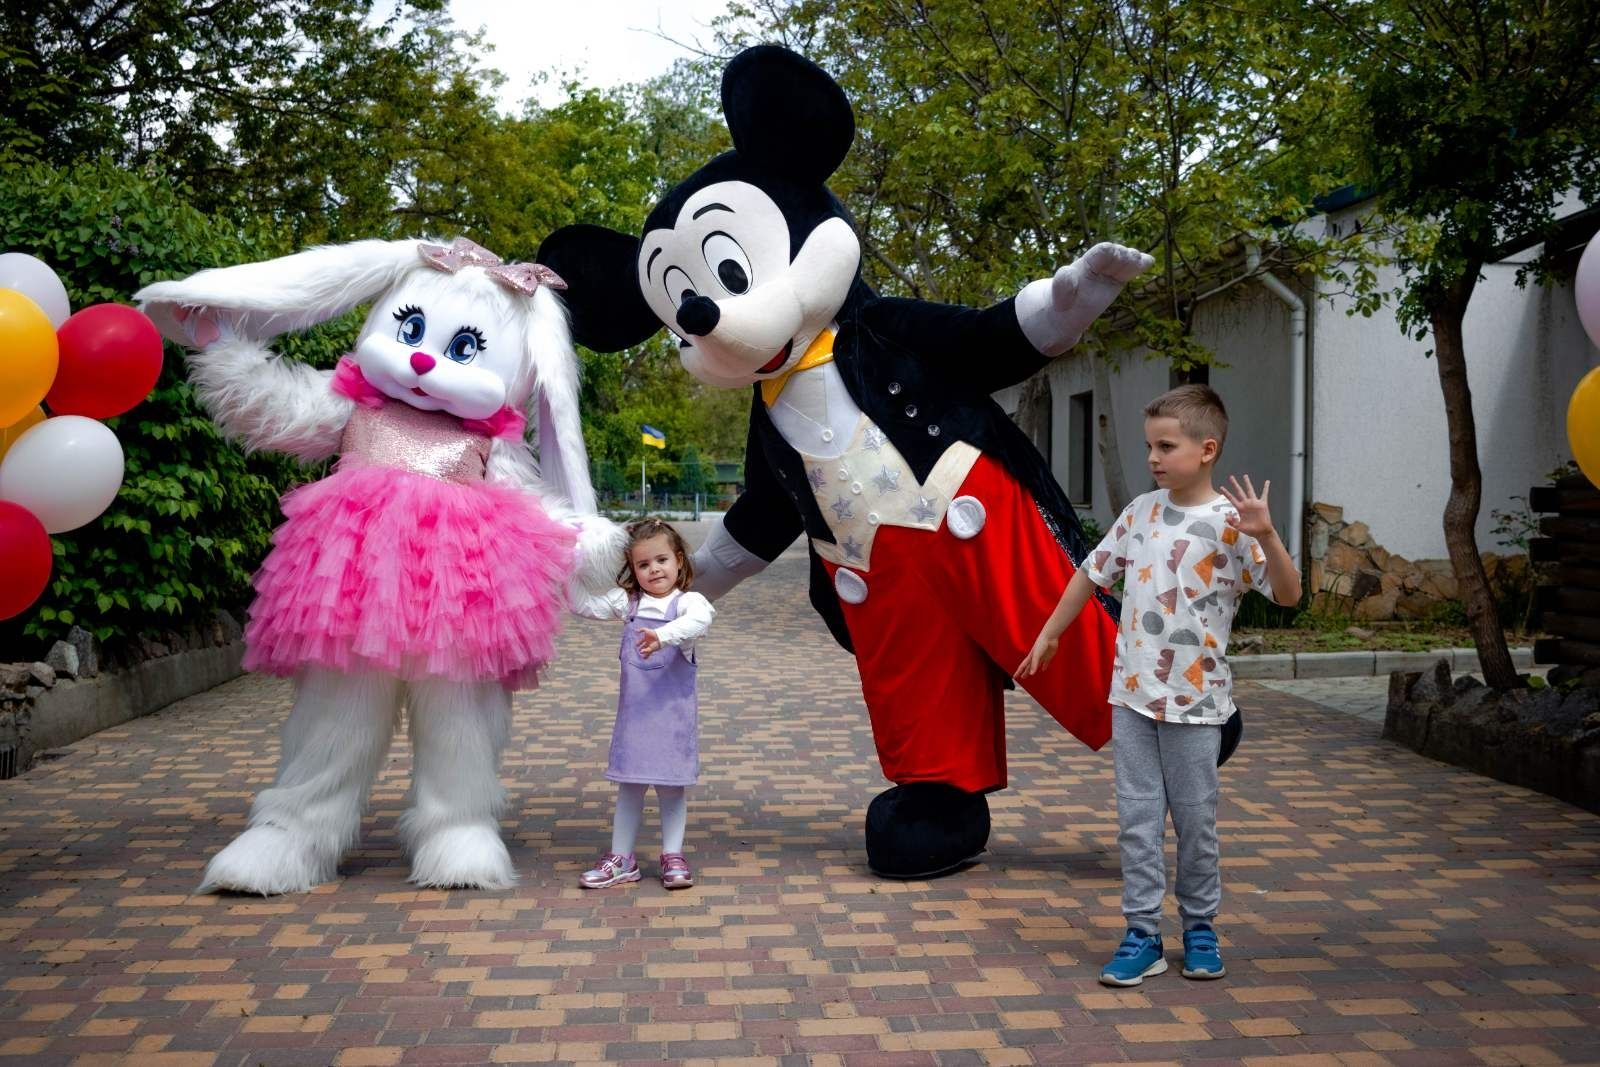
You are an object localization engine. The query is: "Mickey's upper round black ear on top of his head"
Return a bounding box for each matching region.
[722,45,856,182]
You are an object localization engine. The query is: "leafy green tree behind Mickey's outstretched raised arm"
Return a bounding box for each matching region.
[722,0,1357,520]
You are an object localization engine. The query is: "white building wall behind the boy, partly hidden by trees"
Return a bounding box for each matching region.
[998,206,1600,560]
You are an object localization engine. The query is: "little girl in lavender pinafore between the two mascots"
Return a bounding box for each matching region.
[574,518,717,889]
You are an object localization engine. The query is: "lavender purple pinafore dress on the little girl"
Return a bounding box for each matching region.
[605,593,699,785]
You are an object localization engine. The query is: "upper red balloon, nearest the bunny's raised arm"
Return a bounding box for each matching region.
[45,304,162,419]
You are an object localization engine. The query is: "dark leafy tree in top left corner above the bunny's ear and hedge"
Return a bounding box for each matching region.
[0,0,499,243]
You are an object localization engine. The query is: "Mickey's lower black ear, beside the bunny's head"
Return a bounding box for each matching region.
[539,224,661,352]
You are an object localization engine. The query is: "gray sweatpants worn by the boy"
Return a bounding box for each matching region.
[1110,705,1222,934]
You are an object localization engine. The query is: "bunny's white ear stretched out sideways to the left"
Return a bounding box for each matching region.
[133,240,422,344]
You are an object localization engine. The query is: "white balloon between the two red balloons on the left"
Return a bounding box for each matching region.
[0,414,123,533]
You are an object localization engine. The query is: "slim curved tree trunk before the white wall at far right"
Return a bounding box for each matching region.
[1429,278,1522,689]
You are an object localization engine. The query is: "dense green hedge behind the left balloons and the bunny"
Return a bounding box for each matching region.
[0,162,354,661]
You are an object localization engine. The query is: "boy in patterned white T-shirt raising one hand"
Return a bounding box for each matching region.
[1016,386,1299,985]
